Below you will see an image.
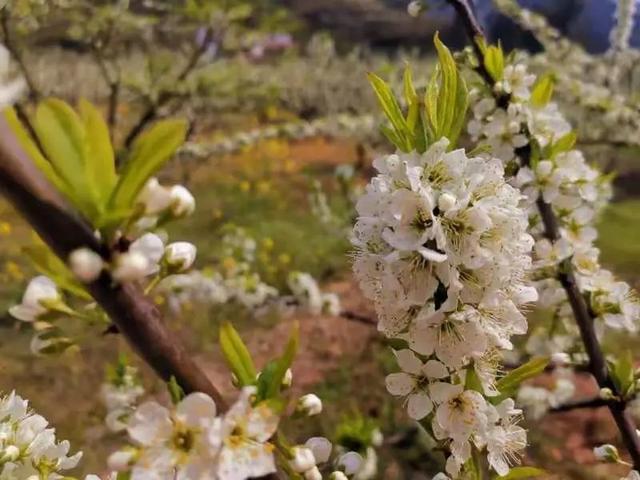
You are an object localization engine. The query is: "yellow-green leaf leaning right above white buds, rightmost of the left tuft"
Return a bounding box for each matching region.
[110,120,187,209]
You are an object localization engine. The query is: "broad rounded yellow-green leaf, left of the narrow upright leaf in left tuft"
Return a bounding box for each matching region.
[33,98,97,219]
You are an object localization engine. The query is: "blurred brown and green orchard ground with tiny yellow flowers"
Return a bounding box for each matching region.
[0,138,640,480]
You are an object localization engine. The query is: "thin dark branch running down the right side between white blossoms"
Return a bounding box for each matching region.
[447,0,640,470]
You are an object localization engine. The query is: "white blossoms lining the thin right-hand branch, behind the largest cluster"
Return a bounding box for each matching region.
[468,61,640,353]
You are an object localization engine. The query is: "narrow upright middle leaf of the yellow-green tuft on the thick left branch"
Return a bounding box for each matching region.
[79,100,117,204]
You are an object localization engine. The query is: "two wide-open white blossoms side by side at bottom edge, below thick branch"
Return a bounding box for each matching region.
[109,387,279,480]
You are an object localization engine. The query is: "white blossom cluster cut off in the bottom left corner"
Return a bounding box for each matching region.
[0,392,82,480]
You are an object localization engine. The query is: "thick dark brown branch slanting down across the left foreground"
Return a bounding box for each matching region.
[0,119,226,409]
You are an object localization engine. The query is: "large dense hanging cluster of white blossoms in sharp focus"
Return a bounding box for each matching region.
[352,138,537,477]
